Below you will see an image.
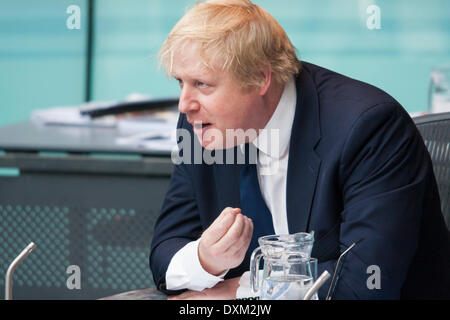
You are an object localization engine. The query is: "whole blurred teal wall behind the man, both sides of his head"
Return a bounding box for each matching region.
[0,0,450,126]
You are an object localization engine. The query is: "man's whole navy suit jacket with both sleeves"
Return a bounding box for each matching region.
[150,62,450,299]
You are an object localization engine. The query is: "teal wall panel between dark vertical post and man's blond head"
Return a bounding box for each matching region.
[93,0,192,100]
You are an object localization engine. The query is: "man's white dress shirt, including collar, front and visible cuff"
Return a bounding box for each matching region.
[166,77,297,291]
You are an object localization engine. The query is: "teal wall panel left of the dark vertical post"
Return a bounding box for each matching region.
[0,0,87,125]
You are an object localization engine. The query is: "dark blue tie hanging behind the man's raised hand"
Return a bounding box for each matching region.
[239,145,275,256]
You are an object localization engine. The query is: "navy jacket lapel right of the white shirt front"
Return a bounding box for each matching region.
[286,68,321,233]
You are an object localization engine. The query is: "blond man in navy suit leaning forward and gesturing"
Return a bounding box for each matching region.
[150,0,450,299]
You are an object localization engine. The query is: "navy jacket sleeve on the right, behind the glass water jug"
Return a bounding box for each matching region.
[318,102,439,299]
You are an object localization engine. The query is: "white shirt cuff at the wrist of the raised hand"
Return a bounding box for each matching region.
[166,239,228,291]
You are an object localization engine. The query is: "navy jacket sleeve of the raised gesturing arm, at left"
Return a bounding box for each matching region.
[149,115,202,294]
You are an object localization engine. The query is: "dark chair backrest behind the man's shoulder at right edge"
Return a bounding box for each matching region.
[413,112,450,229]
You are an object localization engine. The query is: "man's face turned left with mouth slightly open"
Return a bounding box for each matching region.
[172,46,265,149]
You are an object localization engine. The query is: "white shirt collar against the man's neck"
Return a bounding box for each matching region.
[252,77,297,159]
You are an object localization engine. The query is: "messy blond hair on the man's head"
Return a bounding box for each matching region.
[159,0,300,88]
